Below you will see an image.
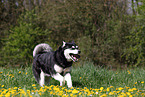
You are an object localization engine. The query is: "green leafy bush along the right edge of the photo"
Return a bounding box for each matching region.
[123,1,145,66]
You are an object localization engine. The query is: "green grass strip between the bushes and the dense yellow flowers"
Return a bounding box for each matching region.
[0,63,145,95]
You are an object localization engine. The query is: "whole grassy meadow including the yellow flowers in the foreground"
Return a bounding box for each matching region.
[0,63,145,97]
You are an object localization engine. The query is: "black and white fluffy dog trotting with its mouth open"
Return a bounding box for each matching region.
[33,41,81,87]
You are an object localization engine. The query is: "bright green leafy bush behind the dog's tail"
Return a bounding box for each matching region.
[1,11,49,66]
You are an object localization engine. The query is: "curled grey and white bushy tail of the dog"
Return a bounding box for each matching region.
[33,43,52,57]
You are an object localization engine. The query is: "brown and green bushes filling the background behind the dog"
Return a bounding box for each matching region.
[0,0,145,66]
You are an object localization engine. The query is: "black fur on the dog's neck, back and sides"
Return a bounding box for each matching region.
[33,47,73,83]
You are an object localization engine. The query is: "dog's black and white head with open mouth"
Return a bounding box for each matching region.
[62,41,81,62]
